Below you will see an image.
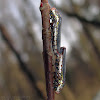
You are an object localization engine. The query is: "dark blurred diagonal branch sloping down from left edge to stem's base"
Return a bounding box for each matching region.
[0,25,45,100]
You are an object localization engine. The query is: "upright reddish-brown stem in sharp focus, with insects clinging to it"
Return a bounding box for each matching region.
[40,0,54,100]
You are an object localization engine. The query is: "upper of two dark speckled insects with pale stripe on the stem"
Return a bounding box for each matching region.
[50,8,62,52]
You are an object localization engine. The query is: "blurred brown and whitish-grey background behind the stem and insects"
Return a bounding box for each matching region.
[0,0,100,100]
